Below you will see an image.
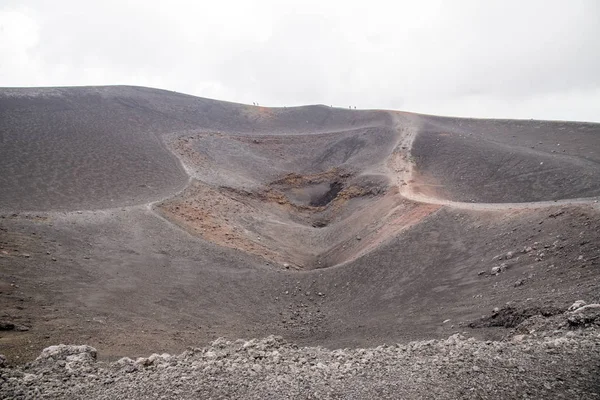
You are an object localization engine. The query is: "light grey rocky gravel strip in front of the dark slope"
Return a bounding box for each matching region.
[0,313,600,399]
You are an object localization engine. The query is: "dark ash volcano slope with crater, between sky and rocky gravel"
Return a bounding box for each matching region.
[0,87,600,397]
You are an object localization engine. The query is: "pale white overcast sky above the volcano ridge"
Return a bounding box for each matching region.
[0,0,600,121]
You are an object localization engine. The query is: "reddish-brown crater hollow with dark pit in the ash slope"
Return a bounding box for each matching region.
[157,135,420,269]
